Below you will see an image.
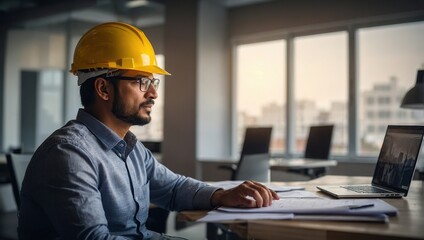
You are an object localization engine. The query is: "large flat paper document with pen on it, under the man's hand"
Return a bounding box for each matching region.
[217,198,397,215]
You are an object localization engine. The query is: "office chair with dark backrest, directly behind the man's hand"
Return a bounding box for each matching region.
[219,127,272,182]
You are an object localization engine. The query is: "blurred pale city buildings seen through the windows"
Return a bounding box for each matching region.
[238,74,424,155]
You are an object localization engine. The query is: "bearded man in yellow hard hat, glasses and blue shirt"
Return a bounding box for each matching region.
[18,22,278,239]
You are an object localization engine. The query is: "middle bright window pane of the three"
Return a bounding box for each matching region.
[294,32,348,155]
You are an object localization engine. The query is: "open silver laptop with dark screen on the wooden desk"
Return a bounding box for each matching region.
[317,125,424,198]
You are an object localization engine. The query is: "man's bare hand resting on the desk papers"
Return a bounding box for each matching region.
[211,181,279,208]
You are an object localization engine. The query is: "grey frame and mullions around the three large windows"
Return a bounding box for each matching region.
[231,13,424,162]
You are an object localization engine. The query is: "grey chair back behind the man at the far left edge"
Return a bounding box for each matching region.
[6,153,32,210]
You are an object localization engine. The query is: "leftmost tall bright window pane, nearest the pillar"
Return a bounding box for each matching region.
[236,40,286,152]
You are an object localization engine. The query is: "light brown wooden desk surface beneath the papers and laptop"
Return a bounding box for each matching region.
[178,176,424,240]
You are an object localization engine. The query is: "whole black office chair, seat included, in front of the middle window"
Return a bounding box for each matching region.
[290,124,334,179]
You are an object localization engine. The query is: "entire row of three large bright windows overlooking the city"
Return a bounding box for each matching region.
[235,20,424,159]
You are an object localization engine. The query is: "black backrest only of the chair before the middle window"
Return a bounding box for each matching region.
[304,125,334,159]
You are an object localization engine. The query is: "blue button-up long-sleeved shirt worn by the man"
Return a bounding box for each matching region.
[18,109,216,239]
